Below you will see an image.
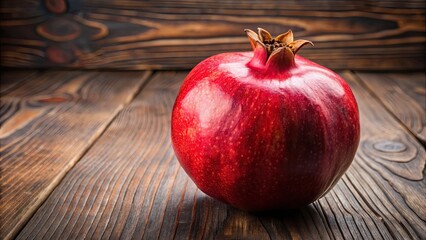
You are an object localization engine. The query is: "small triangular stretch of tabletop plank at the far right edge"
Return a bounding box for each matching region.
[357,73,426,145]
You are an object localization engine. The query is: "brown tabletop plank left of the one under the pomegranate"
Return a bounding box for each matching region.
[0,71,149,239]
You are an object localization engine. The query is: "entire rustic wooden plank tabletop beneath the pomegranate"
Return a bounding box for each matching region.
[0,70,426,239]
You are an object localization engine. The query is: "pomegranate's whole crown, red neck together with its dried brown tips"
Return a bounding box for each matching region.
[244,28,314,68]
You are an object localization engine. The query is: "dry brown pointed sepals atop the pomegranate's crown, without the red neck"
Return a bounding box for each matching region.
[244,28,314,59]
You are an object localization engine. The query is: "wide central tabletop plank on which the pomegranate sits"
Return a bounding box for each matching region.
[18,72,426,239]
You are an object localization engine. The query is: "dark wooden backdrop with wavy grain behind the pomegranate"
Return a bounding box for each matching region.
[0,0,426,70]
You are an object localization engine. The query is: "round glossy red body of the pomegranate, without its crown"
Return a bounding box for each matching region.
[171,52,360,211]
